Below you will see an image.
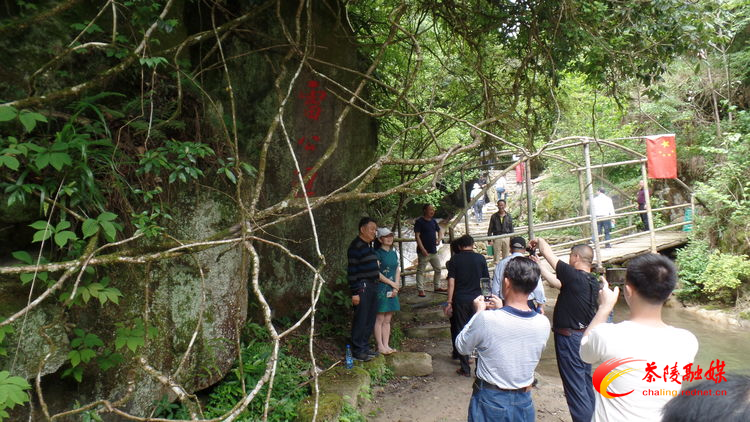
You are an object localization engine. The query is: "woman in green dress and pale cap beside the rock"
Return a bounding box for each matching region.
[374,227,401,355]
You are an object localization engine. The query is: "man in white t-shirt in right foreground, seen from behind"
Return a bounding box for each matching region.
[580,254,698,422]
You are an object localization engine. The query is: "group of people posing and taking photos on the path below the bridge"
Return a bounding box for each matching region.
[348,199,750,422]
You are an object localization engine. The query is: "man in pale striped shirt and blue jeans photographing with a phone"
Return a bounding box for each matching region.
[456,257,550,422]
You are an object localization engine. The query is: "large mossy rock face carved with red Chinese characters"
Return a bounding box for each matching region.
[0,2,377,420]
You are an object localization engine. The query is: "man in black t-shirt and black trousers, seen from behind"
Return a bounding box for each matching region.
[445,235,490,377]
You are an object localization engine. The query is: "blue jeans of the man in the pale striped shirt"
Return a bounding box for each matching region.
[469,384,535,422]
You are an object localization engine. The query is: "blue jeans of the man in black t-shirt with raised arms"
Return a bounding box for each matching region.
[555,331,595,422]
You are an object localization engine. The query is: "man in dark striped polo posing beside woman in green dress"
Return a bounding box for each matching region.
[346,217,380,361]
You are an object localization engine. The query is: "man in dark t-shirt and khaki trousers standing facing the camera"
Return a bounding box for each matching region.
[414,204,445,297]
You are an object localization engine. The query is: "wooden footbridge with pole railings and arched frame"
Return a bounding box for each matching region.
[396,137,695,276]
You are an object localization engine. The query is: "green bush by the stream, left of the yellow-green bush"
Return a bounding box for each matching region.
[675,237,711,300]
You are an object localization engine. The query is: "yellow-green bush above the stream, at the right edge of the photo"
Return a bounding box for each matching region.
[698,253,750,304]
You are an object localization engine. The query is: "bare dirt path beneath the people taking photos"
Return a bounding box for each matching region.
[363,293,570,422]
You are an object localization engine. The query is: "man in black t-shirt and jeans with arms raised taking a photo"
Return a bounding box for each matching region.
[530,238,599,422]
